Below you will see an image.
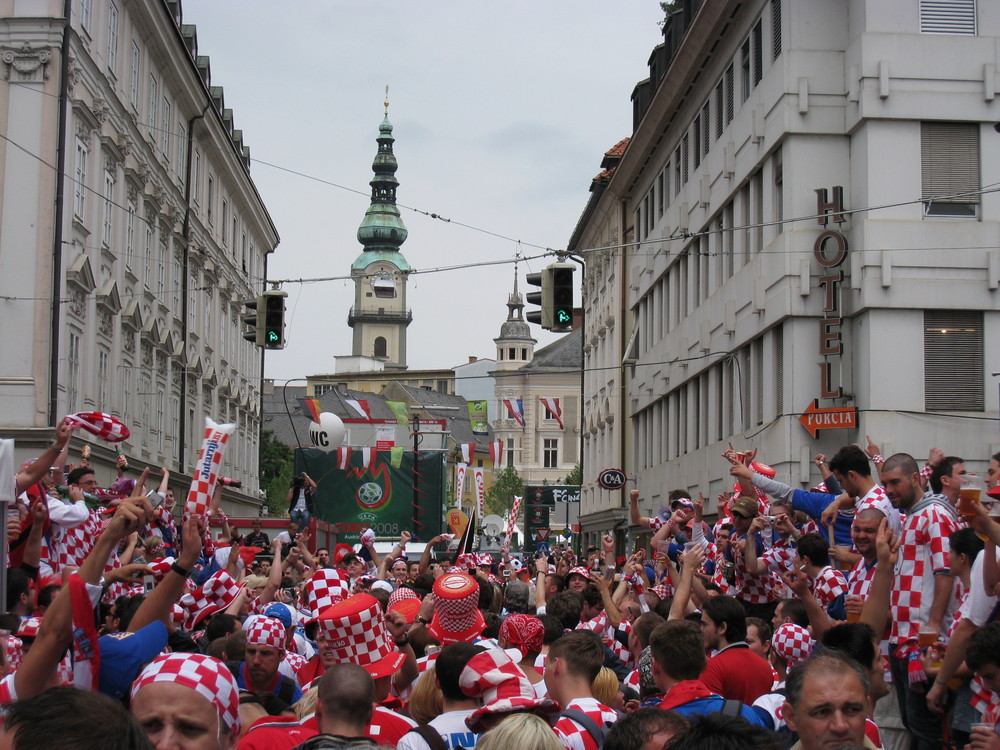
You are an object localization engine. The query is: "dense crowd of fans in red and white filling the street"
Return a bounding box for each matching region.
[0,422,1000,750]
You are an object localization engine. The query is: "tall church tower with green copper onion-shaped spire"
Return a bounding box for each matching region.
[347,94,413,370]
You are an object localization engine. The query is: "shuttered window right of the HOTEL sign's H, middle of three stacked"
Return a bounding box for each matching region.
[920,122,979,217]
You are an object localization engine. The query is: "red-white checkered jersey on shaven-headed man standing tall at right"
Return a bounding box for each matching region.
[889,502,958,644]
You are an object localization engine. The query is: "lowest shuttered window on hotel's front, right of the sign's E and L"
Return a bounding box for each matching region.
[924,310,984,411]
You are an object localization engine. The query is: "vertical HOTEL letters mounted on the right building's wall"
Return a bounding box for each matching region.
[813,185,847,398]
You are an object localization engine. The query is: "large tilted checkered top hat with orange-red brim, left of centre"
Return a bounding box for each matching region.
[319,594,406,678]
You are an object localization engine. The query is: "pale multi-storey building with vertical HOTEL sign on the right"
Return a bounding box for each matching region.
[571,0,1000,534]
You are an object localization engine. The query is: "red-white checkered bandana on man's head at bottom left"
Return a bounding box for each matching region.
[132,653,240,736]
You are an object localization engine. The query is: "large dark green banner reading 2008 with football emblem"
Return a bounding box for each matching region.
[295,448,444,544]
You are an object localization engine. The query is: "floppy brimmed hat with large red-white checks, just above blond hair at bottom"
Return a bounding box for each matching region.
[458,649,559,732]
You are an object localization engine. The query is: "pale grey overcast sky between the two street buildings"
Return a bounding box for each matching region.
[183,0,663,380]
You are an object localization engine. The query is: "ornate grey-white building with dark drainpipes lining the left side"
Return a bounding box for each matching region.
[0,0,278,503]
